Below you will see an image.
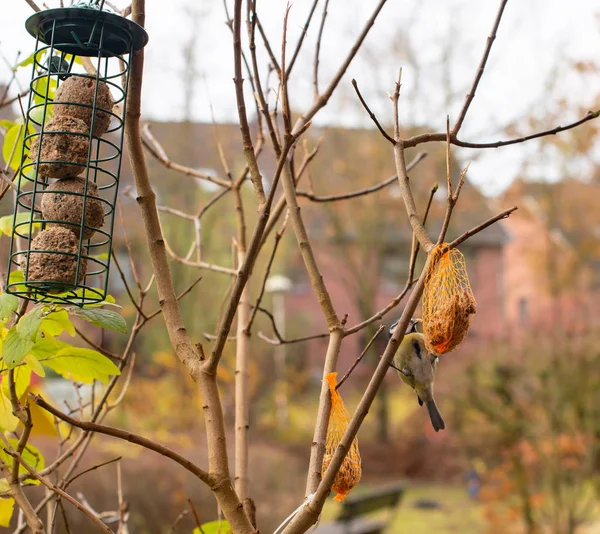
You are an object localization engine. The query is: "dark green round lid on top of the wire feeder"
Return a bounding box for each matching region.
[25,1,148,57]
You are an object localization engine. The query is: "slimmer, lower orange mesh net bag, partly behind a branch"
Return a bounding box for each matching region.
[321,373,362,502]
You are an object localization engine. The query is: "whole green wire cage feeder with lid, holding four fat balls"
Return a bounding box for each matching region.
[6,0,148,306]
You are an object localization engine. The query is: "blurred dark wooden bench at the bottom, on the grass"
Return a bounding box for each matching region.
[314,484,405,534]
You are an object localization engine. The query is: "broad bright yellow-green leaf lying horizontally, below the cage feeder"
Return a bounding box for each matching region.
[43,346,121,384]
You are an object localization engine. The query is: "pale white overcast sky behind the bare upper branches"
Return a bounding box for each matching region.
[0,0,600,195]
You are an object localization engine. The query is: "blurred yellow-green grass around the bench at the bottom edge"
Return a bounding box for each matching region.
[322,485,486,534]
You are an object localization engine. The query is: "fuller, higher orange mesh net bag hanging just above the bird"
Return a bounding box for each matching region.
[423,243,476,356]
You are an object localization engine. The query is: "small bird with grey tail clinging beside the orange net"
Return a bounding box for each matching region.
[389,319,446,432]
